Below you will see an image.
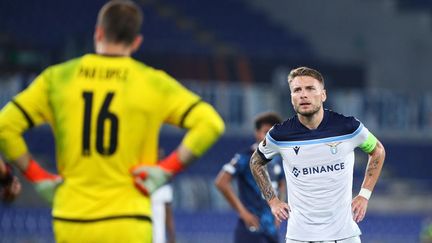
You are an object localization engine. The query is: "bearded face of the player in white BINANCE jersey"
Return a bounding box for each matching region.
[290,76,327,116]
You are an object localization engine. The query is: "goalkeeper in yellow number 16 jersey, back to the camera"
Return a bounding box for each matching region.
[0,1,224,243]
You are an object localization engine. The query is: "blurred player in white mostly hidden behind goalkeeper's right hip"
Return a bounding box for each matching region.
[151,149,175,243]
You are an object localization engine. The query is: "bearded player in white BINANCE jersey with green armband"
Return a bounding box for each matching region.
[250,67,385,243]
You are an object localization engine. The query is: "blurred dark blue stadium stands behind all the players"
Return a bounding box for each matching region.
[0,0,432,243]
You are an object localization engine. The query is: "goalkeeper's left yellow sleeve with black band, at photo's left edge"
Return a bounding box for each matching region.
[0,71,52,160]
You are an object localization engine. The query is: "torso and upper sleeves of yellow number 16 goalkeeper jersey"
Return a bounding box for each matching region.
[0,54,200,220]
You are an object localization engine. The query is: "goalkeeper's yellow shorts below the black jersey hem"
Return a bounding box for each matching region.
[53,218,152,243]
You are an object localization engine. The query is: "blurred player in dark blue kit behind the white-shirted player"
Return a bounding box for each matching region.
[215,112,286,243]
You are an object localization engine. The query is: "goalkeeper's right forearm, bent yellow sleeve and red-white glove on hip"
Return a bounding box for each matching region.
[132,102,225,195]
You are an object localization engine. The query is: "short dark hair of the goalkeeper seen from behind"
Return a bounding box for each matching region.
[97,0,143,44]
